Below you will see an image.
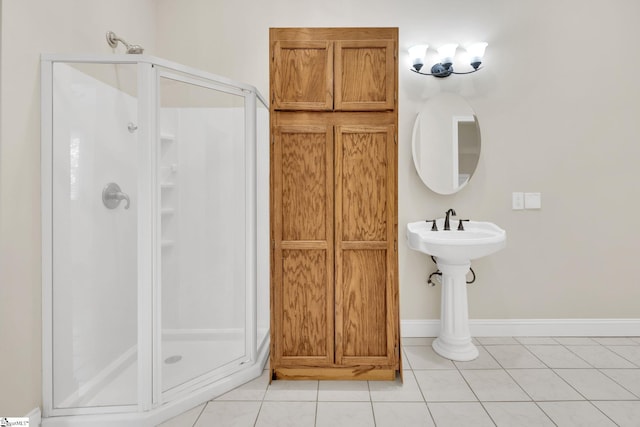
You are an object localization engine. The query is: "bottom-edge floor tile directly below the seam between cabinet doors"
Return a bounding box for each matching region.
[316,402,375,427]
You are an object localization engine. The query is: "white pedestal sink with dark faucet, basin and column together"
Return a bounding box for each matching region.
[407,218,507,362]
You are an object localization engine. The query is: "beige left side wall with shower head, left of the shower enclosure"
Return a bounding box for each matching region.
[0,0,156,416]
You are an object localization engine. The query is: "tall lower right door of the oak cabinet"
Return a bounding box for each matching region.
[335,125,398,366]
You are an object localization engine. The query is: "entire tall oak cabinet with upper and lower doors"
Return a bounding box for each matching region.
[270,28,400,379]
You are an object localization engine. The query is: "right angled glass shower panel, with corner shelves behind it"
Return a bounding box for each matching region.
[157,72,250,401]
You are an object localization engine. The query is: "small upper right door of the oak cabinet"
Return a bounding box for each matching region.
[334,40,396,111]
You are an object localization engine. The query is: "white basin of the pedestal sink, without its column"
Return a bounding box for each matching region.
[407,218,507,262]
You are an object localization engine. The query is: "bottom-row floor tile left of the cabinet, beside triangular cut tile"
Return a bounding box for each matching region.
[195,401,261,427]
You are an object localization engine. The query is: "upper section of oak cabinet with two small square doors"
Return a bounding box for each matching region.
[270,28,398,111]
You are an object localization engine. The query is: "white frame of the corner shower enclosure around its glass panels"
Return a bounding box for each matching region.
[41,54,269,425]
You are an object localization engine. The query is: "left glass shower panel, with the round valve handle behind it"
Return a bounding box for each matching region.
[51,63,140,410]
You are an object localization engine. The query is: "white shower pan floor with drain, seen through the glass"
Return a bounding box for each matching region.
[82,337,245,406]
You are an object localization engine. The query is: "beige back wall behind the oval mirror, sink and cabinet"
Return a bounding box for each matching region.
[157,0,640,319]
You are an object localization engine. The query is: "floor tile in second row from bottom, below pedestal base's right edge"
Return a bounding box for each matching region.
[460,369,531,402]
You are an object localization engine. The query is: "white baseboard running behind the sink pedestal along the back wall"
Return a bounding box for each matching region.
[400,319,640,337]
